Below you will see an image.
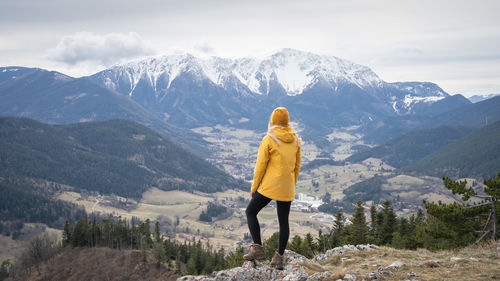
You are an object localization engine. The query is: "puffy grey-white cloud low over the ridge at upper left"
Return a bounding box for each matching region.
[47,32,155,66]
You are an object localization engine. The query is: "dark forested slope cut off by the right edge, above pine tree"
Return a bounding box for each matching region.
[402,119,500,179]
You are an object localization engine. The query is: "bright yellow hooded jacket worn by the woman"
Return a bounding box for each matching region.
[251,108,300,201]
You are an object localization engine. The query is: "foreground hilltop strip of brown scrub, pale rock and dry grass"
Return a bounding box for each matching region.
[12,242,500,281]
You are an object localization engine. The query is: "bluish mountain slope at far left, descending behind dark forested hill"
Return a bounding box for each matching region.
[0,67,206,155]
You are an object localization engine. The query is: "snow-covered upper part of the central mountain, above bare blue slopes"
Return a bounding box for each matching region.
[94,49,383,96]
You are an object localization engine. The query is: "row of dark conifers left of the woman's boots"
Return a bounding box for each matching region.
[63,217,243,274]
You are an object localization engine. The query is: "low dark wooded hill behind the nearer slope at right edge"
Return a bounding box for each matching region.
[346,126,473,168]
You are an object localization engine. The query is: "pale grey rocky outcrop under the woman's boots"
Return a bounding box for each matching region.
[177,245,378,281]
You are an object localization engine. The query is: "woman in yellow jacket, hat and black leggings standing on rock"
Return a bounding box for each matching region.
[243,107,302,269]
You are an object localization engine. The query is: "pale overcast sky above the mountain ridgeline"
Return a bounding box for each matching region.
[0,0,500,96]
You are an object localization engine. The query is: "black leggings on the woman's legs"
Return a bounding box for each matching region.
[245,192,292,255]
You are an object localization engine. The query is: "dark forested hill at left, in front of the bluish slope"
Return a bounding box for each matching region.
[0,118,245,198]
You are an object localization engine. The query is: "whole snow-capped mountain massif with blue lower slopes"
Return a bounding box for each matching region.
[90,49,468,130]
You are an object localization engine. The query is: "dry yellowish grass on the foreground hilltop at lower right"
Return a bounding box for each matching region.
[304,242,500,281]
